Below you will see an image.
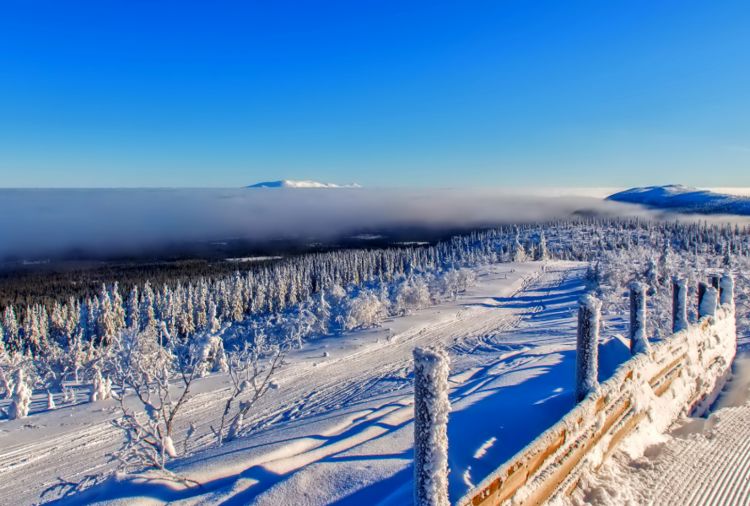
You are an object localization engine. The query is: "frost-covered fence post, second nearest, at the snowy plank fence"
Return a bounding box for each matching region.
[576,295,602,402]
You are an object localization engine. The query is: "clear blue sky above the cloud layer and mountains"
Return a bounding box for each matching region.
[0,0,750,187]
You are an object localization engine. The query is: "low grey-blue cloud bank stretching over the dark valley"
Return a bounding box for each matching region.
[0,189,732,258]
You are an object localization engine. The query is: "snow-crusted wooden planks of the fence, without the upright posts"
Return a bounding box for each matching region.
[458,276,737,506]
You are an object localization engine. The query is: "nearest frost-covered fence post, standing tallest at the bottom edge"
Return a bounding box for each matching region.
[414,348,450,506]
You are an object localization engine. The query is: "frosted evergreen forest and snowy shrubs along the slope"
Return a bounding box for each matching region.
[0,219,750,502]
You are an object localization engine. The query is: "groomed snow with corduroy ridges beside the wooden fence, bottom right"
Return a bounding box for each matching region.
[570,354,750,506]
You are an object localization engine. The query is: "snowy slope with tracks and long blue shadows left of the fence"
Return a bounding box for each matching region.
[0,262,629,504]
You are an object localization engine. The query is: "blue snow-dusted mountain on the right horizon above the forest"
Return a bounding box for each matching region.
[607,184,750,216]
